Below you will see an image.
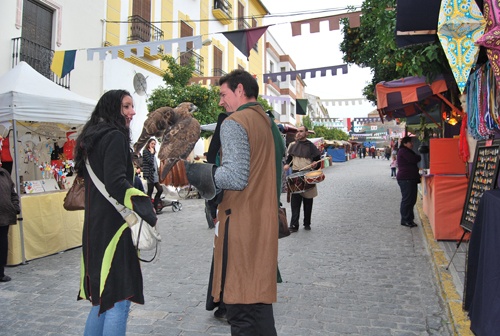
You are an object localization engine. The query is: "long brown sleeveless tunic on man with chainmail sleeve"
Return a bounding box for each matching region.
[212,105,278,304]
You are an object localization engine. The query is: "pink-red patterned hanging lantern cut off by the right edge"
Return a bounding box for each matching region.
[476,0,500,86]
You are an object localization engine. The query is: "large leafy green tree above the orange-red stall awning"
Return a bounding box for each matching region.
[340,0,458,102]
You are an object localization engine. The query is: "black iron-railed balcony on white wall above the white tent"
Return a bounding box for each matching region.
[12,37,71,89]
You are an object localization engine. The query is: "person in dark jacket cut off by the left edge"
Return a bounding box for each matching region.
[0,167,21,282]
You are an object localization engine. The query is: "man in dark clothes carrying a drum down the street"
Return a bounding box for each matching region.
[283,126,321,232]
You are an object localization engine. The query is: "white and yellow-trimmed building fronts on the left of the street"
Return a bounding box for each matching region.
[0,0,268,139]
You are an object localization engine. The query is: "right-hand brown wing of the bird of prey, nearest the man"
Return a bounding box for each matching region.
[158,116,200,181]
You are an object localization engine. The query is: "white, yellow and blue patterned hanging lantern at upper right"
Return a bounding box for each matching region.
[437,0,486,93]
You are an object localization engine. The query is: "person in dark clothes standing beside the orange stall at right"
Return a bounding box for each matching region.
[396,136,422,228]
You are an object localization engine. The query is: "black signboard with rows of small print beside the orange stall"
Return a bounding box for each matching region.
[460,139,500,232]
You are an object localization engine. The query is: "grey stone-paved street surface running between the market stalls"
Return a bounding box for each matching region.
[0,158,460,336]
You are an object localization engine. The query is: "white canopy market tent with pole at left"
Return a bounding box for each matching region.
[0,62,96,262]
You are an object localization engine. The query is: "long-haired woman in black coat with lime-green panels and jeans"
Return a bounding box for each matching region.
[75,90,157,335]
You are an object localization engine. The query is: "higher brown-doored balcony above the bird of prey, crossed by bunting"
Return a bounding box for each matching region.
[128,15,164,60]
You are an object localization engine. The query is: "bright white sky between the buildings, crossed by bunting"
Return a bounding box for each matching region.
[263,0,375,118]
